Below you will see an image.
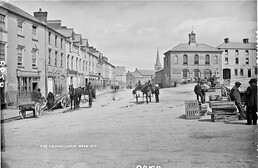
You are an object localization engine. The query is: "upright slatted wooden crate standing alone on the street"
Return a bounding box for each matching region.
[185,100,201,119]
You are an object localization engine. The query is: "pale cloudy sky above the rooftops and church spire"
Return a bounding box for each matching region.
[7,0,257,71]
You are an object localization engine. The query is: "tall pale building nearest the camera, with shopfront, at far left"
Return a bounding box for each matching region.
[0,3,48,104]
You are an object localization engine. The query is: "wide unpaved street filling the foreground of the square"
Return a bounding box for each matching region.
[2,84,258,168]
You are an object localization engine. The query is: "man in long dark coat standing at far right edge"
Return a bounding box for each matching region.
[245,79,257,125]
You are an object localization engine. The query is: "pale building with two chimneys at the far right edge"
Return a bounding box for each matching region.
[217,38,257,81]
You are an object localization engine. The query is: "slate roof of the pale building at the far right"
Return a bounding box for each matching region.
[217,42,256,50]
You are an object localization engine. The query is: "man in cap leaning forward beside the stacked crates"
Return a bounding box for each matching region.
[230,82,245,120]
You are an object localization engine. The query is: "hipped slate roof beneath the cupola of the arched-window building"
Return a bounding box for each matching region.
[167,43,221,52]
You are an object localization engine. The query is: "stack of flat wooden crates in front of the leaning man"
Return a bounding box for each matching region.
[210,101,238,122]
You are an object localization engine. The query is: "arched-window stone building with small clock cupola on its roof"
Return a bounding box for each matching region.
[164,32,222,87]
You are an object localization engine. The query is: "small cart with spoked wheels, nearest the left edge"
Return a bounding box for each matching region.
[17,92,46,118]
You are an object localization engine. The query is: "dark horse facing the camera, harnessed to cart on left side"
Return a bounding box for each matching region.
[69,85,81,110]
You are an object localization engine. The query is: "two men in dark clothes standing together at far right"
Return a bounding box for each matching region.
[230,79,257,125]
